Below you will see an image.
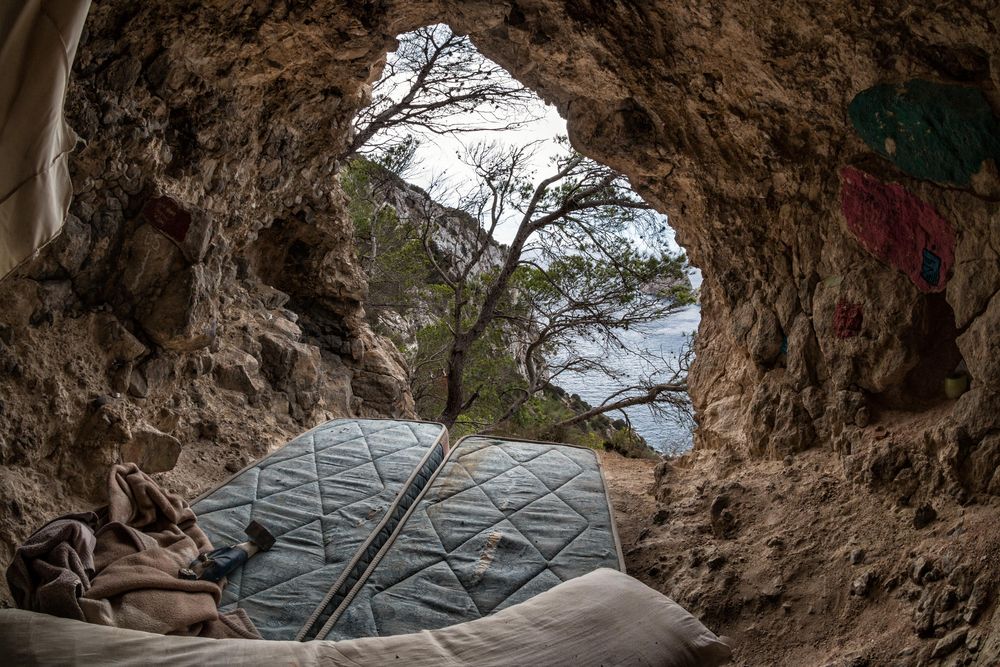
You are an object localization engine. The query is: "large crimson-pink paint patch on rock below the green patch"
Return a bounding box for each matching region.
[840,167,955,292]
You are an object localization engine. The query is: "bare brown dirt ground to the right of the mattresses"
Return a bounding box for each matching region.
[603,451,1000,667]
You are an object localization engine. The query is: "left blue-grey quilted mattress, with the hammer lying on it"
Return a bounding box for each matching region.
[193,419,448,640]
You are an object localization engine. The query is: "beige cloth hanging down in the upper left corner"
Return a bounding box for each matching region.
[0,0,90,278]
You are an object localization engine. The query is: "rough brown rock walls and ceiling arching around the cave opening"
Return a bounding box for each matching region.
[0,0,1000,664]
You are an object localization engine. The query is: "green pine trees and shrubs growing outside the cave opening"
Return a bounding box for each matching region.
[341,141,694,448]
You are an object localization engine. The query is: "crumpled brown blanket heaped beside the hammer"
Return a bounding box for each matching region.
[7,463,260,639]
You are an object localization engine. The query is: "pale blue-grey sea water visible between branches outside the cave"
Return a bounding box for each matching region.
[556,305,701,454]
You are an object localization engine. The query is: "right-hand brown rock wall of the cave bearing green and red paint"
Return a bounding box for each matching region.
[464,1,1000,499]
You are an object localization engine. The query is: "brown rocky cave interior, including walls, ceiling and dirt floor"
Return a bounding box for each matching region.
[0,0,1000,665]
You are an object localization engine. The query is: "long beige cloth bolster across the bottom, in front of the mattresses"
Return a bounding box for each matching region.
[0,569,729,667]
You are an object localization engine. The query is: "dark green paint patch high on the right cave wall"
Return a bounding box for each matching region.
[848,79,1000,190]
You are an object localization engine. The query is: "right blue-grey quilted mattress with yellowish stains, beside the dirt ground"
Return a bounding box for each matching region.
[299,436,624,639]
